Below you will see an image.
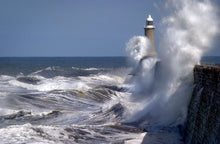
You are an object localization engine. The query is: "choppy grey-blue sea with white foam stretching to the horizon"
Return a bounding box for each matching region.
[0,57,220,144]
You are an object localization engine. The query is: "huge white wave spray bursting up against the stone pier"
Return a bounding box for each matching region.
[126,0,219,127]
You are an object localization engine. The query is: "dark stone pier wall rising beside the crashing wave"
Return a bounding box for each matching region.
[184,64,220,144]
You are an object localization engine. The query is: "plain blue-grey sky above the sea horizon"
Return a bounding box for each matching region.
[0,0,220,57]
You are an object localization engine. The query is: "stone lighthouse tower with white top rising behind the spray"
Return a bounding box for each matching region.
[144,14,157,56]
